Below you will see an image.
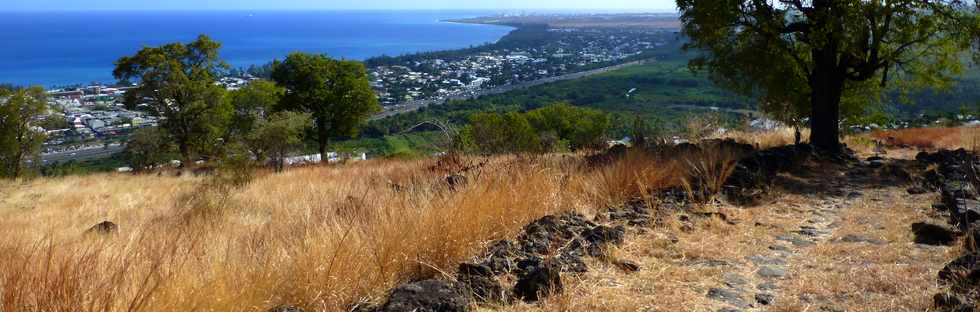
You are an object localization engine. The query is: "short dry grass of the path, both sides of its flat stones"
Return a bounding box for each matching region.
[516,156,959,312]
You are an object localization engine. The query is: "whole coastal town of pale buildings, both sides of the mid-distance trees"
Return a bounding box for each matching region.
[36,27,679,164]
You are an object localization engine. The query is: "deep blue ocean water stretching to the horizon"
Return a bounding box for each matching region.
[0,11,511,87]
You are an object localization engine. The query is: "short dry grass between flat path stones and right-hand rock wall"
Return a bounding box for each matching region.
[779,188,958,311]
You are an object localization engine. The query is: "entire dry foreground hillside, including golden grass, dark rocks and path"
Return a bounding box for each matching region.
[0,129,980,312]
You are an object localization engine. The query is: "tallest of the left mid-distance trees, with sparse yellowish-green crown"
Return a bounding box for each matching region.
[113,35,231,164]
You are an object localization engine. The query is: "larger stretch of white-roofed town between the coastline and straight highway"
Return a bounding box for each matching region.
[367,27,679,108]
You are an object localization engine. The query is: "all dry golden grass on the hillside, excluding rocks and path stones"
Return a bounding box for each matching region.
[0,125,976,311]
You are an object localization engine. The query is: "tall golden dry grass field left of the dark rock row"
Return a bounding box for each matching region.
[0,147,736,311]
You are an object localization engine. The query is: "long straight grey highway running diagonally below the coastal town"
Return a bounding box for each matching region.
[371,60,651,120]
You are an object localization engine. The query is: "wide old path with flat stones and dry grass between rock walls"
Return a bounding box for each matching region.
[488,154,952,312]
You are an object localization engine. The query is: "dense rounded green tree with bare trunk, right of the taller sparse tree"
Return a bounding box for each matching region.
[272,53,381,155]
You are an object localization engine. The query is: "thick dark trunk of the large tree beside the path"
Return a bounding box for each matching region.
[810,50,844,153]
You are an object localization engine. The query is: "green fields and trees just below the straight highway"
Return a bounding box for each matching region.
[363,60,751,137]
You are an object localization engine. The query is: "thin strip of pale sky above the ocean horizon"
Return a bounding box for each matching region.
[0,0,676,12]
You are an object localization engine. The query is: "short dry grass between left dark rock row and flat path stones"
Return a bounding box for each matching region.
[498,201,768,312]
